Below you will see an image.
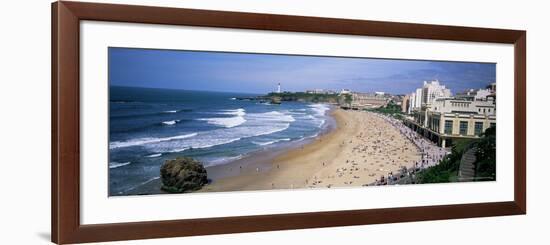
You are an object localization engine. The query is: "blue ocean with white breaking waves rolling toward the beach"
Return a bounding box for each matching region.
[108,86,330,196]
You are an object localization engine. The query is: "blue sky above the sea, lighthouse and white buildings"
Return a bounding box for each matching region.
[109,48,496,94]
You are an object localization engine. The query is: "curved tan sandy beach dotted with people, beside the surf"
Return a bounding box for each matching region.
[201,109,421,192]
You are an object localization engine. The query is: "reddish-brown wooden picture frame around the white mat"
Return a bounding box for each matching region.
[51,1,526,244]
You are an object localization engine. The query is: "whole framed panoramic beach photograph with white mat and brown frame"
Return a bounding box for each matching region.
[52,1,526,244]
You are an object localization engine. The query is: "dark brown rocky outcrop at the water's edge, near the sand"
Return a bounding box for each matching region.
[160,157,208,193]
